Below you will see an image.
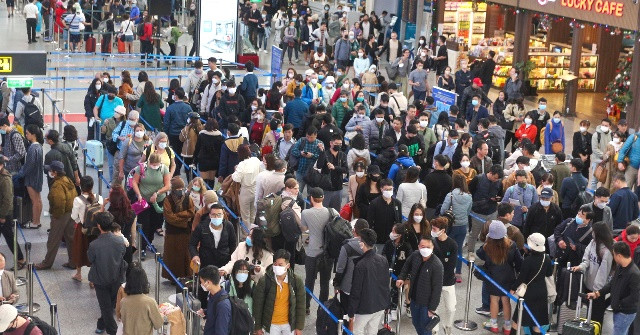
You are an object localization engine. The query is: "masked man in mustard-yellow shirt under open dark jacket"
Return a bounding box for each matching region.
[252,249,306,335]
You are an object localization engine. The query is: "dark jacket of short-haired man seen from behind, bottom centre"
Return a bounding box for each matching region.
[348,249,390,316]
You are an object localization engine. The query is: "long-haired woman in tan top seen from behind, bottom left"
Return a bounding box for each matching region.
[117,262,164,335]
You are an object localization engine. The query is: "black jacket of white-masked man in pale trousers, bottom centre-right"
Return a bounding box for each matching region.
[398,250,444,311]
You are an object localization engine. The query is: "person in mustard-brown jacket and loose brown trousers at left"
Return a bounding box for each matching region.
[35,160,78,270]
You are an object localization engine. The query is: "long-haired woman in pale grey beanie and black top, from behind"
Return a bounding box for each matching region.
[476,220,524,334]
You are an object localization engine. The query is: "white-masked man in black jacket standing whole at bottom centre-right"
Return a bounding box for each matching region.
[396,235,444,335]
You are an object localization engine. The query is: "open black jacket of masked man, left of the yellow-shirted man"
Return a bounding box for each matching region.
[189,220,237,267]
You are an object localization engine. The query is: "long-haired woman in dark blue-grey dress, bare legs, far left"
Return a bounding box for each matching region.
[16,124,44,229]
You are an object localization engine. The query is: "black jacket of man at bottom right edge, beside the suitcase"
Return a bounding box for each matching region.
[600,262,640,314]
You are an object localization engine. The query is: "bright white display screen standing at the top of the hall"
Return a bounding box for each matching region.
[199,0,238,63]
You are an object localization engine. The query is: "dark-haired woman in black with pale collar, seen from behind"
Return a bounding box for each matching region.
[193,118,224,189]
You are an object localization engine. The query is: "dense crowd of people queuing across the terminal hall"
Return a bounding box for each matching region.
[0,0,640,335]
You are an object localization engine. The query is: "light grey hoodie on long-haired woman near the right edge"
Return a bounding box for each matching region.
[580,240,613,291]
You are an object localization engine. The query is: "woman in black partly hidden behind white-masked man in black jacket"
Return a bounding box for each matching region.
[382,223,414,320]
